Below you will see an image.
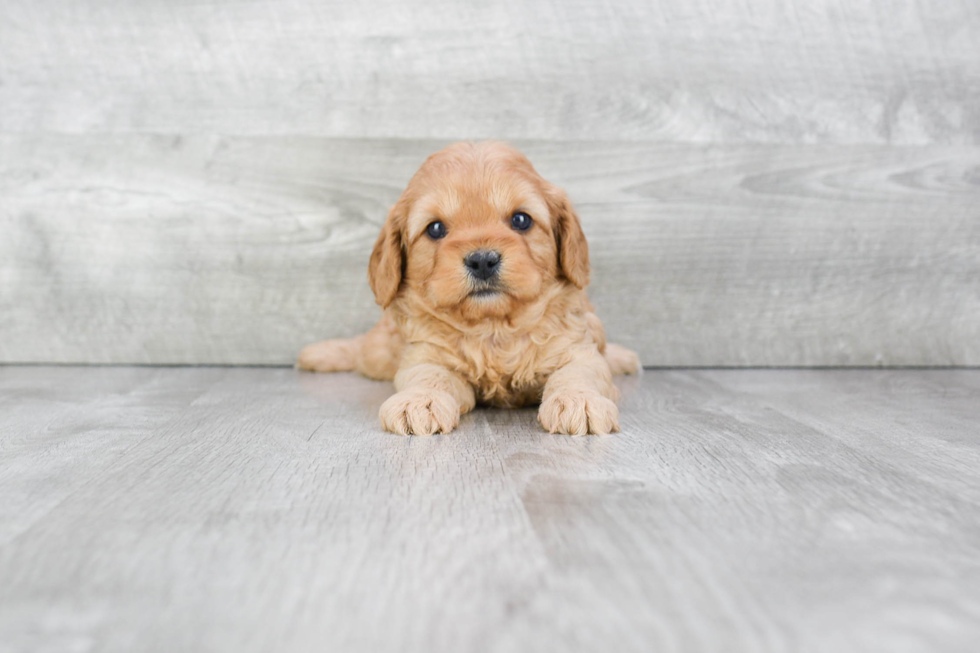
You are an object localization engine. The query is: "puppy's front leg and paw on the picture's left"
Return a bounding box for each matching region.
[379,363,476,435]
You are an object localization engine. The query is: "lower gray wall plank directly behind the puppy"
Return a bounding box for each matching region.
[0,135,980,366]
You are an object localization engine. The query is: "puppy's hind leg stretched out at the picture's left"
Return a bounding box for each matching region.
[296,312,402,381]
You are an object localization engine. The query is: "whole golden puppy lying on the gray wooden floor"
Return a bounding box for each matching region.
[298,141,639,435]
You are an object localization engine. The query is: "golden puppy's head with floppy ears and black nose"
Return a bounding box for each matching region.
[368,141,589,320]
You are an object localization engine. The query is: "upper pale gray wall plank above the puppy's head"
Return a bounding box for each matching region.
[0,0,980,145]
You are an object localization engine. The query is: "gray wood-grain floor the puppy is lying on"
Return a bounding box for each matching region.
[0,367,980,653]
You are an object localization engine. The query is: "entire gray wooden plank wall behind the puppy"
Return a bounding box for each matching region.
[0,0,980,366]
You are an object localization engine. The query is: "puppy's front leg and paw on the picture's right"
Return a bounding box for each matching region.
[538,346,619,435]
